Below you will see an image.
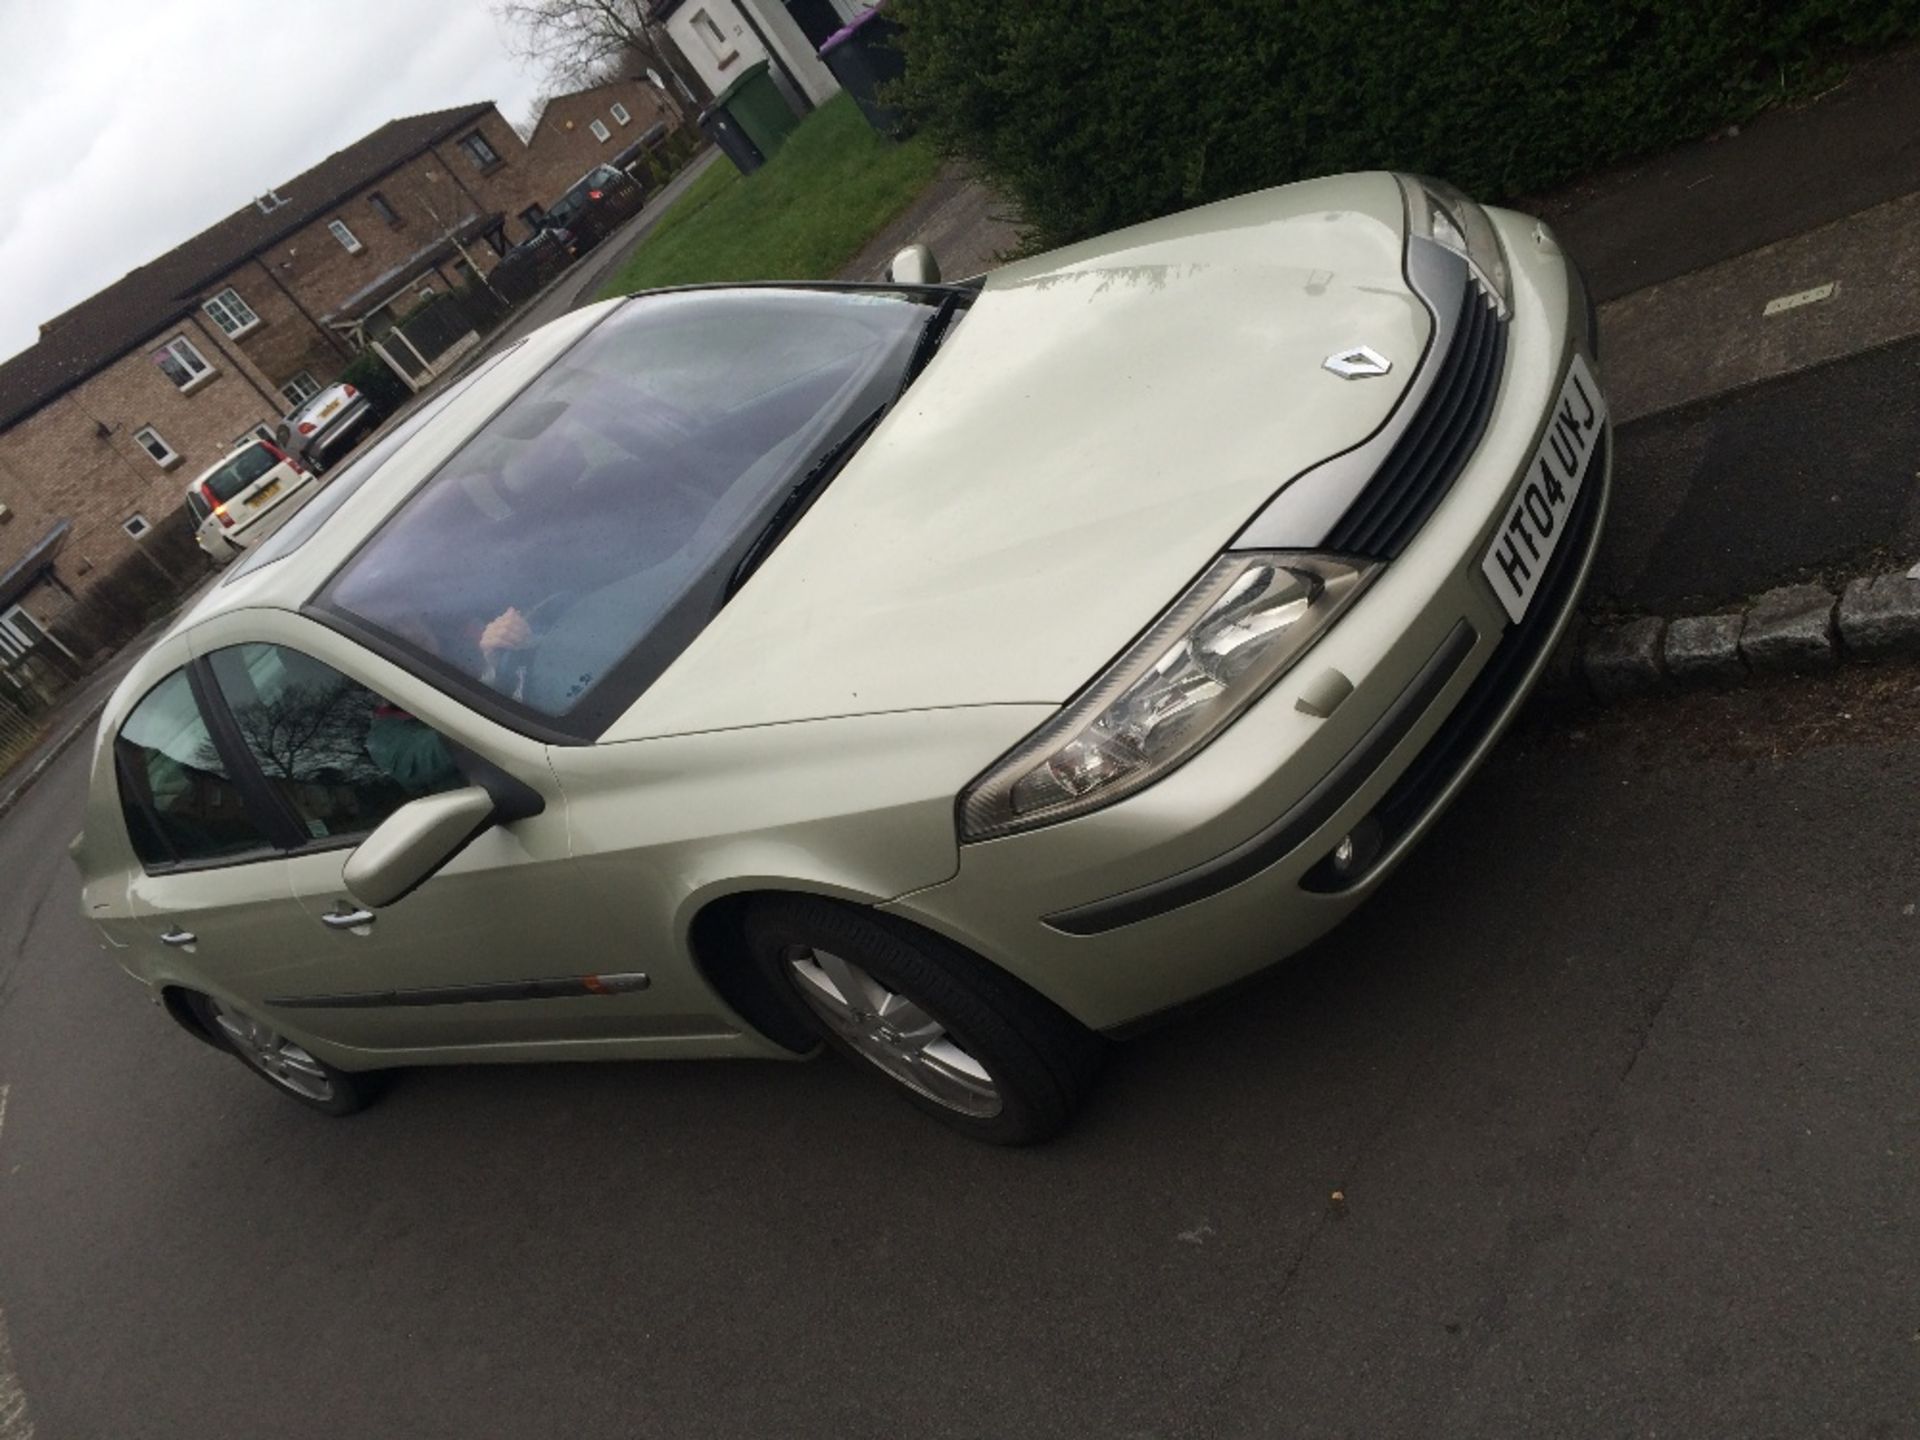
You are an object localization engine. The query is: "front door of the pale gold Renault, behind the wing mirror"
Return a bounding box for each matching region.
[187,616,728,1054]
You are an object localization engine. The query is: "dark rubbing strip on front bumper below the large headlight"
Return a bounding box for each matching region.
[1044,620,1478,935]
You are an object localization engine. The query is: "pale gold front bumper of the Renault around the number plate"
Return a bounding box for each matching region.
[885,211,1613,1029]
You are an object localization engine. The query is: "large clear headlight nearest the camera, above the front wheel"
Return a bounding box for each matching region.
[960,551,1377,841]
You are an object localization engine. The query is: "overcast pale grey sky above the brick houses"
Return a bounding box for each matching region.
[0,0,540,359]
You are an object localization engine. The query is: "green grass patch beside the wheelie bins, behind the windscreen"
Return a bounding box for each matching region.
[599,94,939,300]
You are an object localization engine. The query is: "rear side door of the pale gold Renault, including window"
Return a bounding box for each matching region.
[111,655,307,1004]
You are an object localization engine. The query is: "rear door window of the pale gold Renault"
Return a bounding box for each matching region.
[113,670,269,870]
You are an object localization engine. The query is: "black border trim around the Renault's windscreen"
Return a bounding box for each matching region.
[300,276,985,747]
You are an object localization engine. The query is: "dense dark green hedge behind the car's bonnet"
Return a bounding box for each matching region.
[887,0,1920,244]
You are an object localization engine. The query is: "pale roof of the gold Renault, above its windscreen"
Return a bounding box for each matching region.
[169,300,624,634]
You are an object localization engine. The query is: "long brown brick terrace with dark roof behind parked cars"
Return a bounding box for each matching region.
[0,86,675,649]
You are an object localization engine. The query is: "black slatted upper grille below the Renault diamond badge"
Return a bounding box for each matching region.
[1325,282,1507,561]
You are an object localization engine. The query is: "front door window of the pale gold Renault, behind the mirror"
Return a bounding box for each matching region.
[211,645,467,841]
